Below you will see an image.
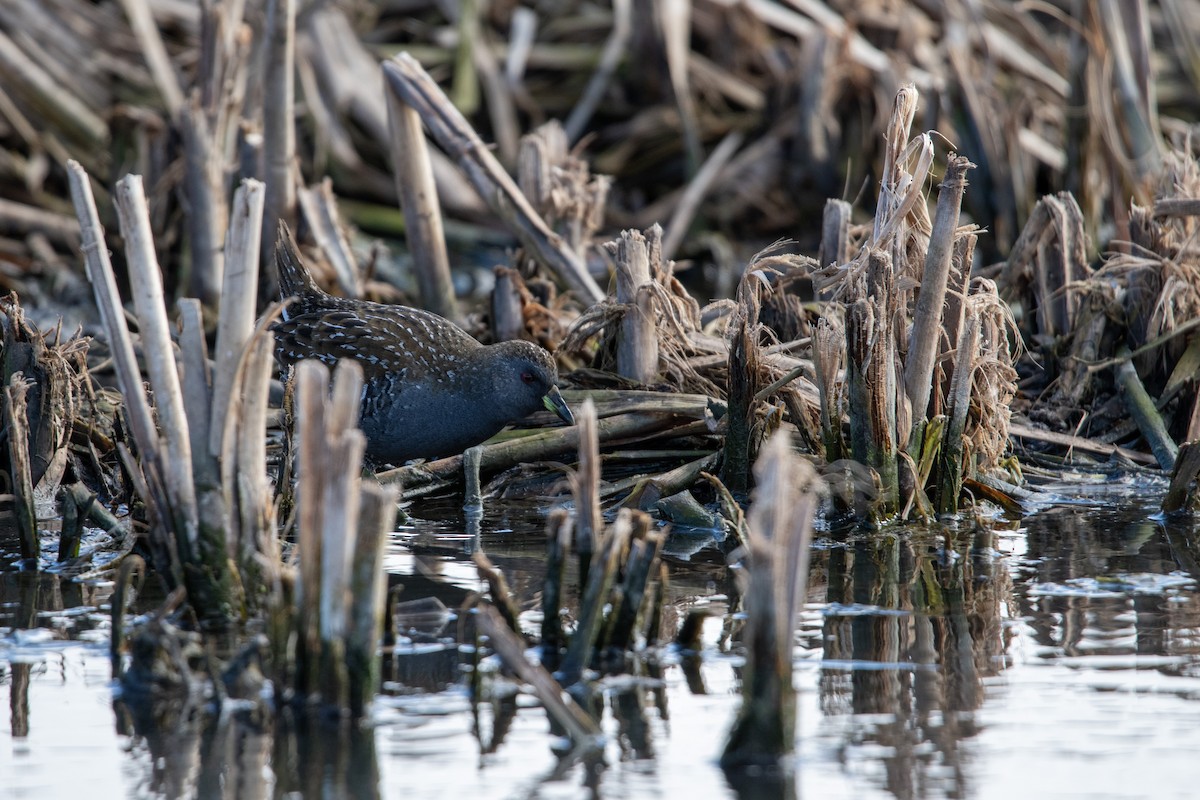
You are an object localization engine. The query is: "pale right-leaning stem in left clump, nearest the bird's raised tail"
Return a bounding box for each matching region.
[208,180,266,456]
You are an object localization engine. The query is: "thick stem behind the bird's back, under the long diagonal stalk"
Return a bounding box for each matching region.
[384,81,458,319]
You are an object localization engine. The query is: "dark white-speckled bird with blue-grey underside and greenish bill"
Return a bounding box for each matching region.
[272,222,575,465]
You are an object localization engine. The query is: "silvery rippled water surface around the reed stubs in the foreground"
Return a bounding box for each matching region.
[0,480,1200,800]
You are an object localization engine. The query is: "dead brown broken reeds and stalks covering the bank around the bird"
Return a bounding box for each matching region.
[0,0,1200,739]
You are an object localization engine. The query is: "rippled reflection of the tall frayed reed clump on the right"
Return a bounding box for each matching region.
[814,528,1012,799]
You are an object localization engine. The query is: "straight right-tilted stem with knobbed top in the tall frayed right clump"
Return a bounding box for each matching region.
[904,152,974,443]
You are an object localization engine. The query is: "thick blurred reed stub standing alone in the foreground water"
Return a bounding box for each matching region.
[721,432,820,770]
